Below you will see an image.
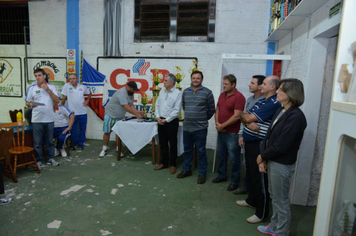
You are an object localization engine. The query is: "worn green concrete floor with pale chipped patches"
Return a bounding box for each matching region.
[0,140,315,236]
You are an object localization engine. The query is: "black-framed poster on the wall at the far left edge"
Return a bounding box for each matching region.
[0,57,23,97]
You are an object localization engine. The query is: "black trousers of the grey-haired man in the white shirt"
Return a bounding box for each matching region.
[158,118,179,166]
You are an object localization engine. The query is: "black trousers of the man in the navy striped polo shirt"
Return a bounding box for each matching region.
[244,141,269,219]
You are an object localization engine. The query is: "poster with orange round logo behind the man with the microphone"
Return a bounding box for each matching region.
[24,57,67,94]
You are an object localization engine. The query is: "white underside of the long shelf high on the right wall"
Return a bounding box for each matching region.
[265,0,328,41]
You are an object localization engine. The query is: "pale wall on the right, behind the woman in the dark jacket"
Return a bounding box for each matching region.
[277,0,340,205]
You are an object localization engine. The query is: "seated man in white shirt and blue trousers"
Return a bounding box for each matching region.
[53,104,74,157]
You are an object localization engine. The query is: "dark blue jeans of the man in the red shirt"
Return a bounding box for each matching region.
[217,132,241,185]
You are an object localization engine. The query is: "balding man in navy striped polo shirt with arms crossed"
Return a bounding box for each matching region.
[236,75,281,224]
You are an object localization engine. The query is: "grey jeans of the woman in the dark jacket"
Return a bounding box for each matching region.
[267,161,295,236]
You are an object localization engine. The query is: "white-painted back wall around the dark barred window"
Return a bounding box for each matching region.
[0,0,269,148]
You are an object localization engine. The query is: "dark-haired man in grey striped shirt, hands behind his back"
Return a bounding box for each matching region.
[177,71,215,184]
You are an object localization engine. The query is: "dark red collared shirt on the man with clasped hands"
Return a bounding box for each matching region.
[217,89,246,133]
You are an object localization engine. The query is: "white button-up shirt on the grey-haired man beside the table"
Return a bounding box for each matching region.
[155,87,182,123]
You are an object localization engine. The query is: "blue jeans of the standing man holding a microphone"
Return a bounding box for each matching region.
[32,122,54,163]
